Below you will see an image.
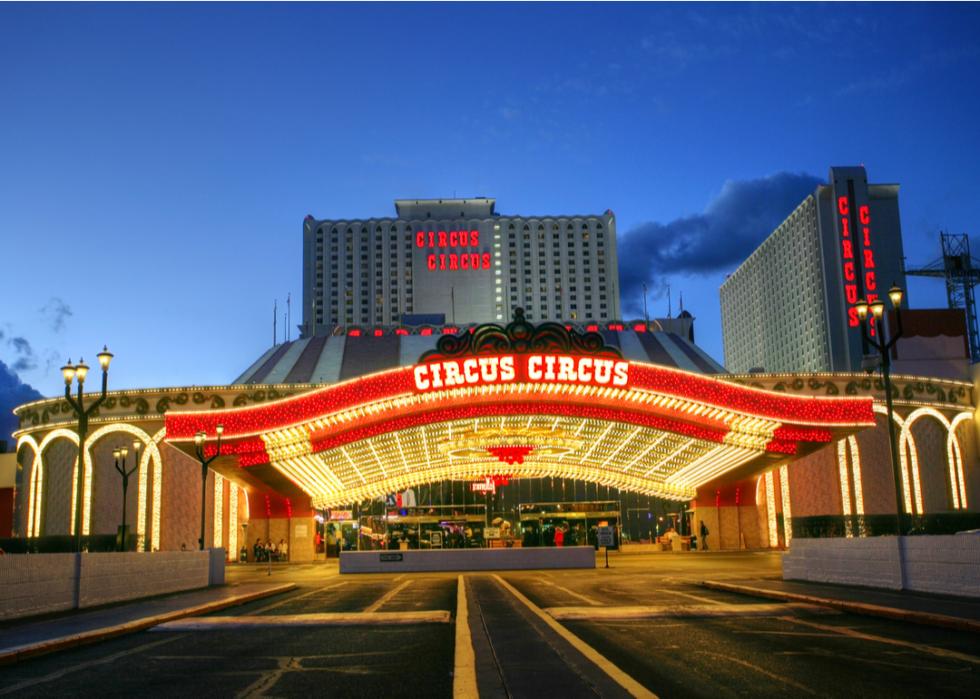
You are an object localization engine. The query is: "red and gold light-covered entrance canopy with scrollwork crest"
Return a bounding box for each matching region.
[166,316,874,507]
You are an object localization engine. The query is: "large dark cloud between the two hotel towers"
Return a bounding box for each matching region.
[618,172,823,313]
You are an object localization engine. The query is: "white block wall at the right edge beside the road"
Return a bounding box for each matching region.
[783,534,980,597]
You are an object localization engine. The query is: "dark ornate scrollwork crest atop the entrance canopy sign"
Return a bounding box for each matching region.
[420,308,623,364]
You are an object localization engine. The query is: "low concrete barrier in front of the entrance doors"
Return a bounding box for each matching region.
[340,546,595,573]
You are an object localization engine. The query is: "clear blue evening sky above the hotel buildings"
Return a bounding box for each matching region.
[0,3,980,426]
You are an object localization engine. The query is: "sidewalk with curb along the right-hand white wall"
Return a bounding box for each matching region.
[701,579,980,632]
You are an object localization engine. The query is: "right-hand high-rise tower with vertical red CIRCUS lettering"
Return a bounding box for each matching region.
[720,167,908,373]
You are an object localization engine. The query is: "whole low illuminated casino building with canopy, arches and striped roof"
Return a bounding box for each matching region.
[14,313,980,561]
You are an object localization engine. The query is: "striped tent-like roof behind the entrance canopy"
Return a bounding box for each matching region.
[234,327,725,384]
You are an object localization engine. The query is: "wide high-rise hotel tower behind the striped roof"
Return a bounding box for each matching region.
[302,198,620,337]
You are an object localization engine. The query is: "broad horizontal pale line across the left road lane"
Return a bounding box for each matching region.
[150,610,452,631]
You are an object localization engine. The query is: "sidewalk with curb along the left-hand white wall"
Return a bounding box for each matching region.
[0,582,296,665]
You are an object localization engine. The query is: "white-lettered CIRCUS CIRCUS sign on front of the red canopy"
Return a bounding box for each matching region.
[413,354,629,391]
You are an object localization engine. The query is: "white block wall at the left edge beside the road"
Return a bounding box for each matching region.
[0,549,224,620]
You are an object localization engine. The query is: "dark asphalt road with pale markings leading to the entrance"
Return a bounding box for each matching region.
[0,553,980,699]
